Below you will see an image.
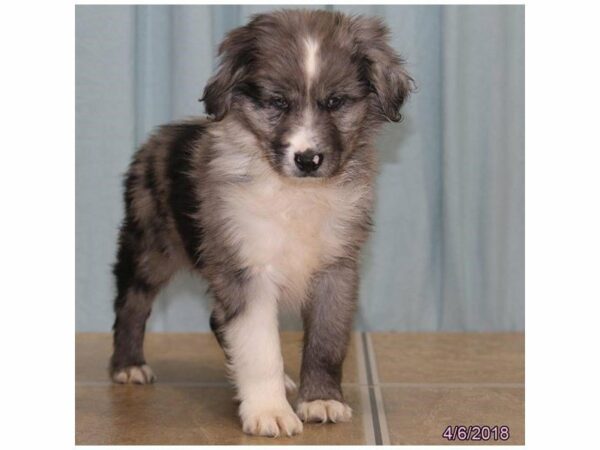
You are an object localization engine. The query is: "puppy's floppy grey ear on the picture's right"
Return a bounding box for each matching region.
[355,16,415,122]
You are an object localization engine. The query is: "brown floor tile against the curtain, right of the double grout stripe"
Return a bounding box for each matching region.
[371,333,525,383]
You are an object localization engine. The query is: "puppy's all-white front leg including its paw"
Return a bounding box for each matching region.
[222,271,302,436]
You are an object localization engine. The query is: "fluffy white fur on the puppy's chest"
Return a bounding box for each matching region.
[219,172,361,297]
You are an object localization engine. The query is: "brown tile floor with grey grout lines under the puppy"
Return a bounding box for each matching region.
[75,332,525,445]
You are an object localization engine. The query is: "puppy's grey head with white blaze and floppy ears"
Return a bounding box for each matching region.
[203,11,413,177]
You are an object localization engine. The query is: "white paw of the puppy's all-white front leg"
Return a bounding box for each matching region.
[240,401,302,437]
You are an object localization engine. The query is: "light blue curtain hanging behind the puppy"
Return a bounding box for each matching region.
[76,5,524,331]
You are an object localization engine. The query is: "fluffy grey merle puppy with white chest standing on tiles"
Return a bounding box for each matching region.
[110,10,412,436]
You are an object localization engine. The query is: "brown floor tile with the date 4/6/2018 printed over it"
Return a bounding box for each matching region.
[382,386,525,445]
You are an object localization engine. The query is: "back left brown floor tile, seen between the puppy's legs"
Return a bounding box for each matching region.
[75,332,358,383]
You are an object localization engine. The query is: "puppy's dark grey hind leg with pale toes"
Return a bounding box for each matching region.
[110,222,173,384]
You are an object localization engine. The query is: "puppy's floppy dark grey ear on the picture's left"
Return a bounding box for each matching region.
[200,23,254,120]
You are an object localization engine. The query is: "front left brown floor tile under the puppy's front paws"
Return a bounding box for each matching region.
[76,384,364,445]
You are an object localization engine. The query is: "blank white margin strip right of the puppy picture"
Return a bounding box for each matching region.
[525,2,600,448]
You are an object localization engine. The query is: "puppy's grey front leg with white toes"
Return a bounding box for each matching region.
[297,260,358,422]
